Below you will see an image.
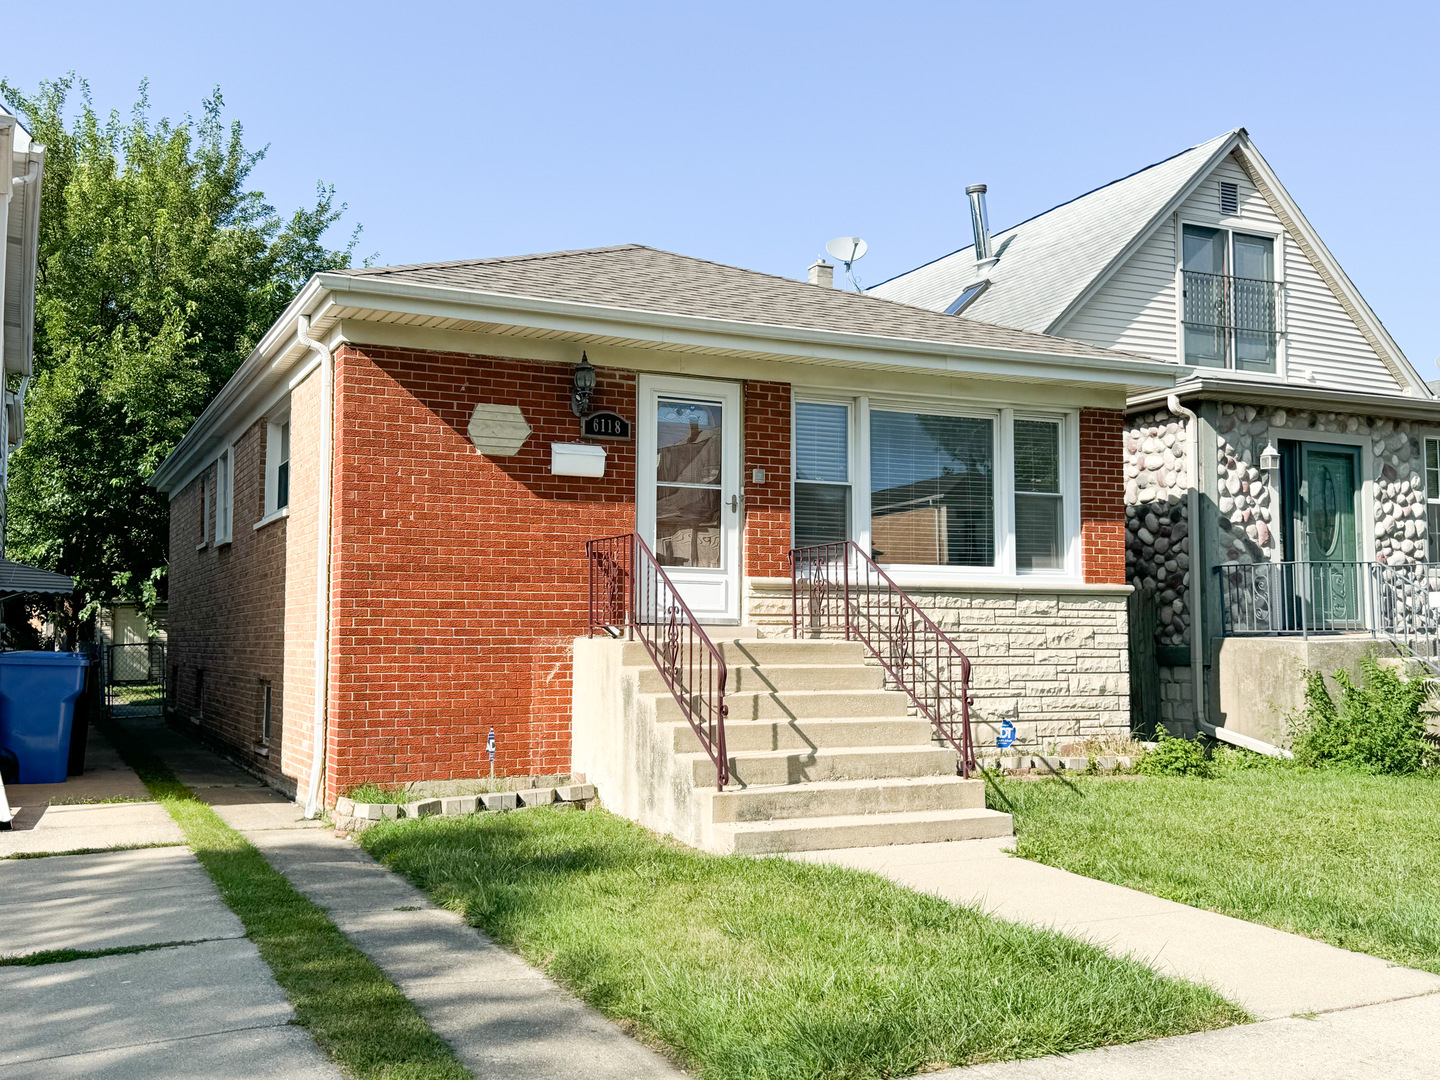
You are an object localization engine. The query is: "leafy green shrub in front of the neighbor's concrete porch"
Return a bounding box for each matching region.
[1295,657,1436,775]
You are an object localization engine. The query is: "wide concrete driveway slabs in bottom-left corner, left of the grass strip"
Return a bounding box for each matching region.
[0,848,340,1080]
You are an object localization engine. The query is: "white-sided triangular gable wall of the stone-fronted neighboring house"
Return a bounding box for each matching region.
[1051,154,1405,393]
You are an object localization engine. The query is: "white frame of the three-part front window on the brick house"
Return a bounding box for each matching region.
[791,387,1083,585]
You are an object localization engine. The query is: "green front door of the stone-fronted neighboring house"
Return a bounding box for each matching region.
[1297,442,1364,629]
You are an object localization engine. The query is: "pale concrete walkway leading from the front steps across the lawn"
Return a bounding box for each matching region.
[792,840,1440,1025]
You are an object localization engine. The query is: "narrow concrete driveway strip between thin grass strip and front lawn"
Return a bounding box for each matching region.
[246,829,684,1080]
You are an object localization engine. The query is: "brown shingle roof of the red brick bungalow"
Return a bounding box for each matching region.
[337,243,1140,360]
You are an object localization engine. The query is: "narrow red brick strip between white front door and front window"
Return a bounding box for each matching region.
[742,383,791,577]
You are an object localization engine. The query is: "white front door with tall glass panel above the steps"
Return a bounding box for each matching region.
[635,376,742,622]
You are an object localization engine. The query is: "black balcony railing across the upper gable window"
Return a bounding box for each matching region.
[1182,271,1280,372]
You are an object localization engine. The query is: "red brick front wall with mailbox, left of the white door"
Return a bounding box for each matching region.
[327,346,635,799]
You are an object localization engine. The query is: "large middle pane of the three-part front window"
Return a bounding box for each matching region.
[870,409,995,566]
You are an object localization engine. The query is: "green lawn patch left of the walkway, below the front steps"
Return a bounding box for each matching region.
[360,809,1247,1080]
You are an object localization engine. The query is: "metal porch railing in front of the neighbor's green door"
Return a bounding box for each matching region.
[1215,560,1440,671]
